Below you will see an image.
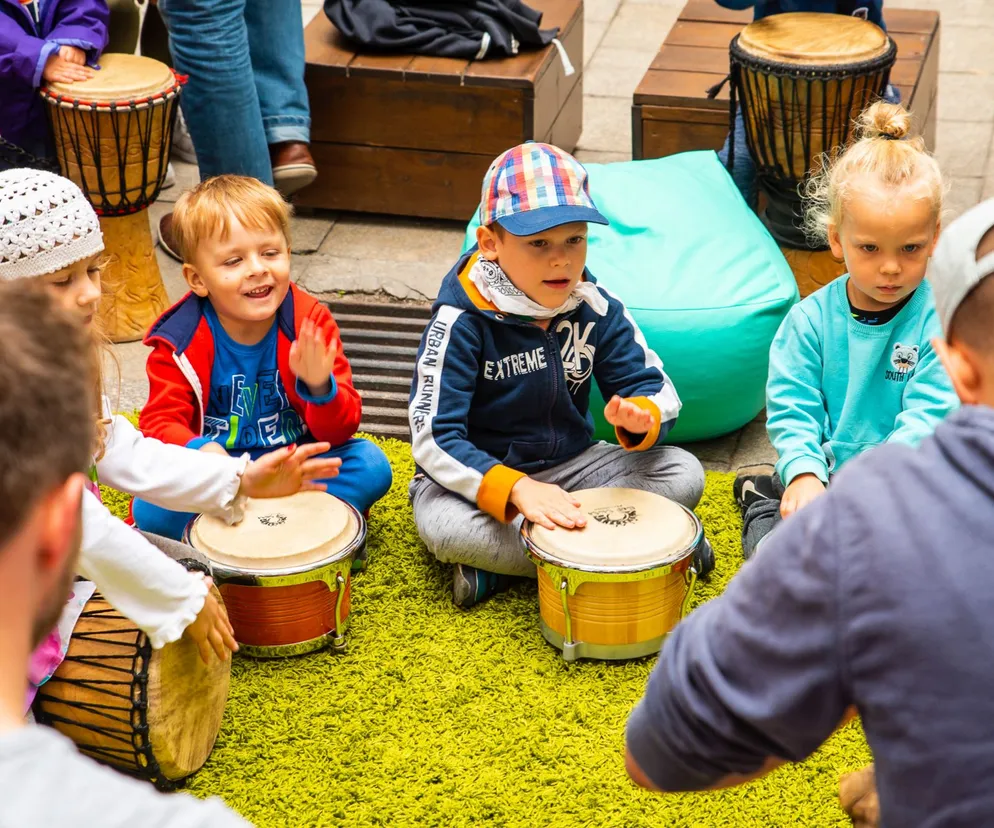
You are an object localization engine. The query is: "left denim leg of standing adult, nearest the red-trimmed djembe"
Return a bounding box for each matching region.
[159,0,273,185]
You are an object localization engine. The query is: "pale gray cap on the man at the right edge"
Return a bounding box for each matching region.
[928,198,994,334]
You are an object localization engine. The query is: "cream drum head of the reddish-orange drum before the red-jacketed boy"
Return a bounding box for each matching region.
[190,492,359,571]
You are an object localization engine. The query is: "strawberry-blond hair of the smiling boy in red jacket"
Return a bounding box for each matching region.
[172,175,292,262]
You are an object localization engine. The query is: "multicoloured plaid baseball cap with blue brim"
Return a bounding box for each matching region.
[480,142,608,236]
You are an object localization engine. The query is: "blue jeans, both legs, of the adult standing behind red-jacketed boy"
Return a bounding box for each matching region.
[159,0,311,185]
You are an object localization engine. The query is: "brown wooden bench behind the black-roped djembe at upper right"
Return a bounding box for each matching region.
[632,0,939,158]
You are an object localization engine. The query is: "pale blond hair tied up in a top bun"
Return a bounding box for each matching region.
[803,101,944,245]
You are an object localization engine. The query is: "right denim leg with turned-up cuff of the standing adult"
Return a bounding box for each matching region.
[242,0,311,144]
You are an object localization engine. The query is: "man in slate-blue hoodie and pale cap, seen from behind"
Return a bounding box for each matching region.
[627,200,994,828]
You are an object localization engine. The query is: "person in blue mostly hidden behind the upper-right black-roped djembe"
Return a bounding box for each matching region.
[716,0,901,210]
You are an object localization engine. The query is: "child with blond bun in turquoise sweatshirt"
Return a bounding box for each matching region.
[734,102,957,558]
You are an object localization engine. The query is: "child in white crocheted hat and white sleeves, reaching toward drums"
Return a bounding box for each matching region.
[0,169,341,700]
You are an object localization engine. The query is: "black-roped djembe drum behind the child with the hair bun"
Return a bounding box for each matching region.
[729,12,897,295]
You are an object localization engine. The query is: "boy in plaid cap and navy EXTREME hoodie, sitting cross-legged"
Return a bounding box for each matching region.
[409,143,713,607]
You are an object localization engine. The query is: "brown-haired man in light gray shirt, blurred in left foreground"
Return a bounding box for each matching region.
[0,284,248,828]
